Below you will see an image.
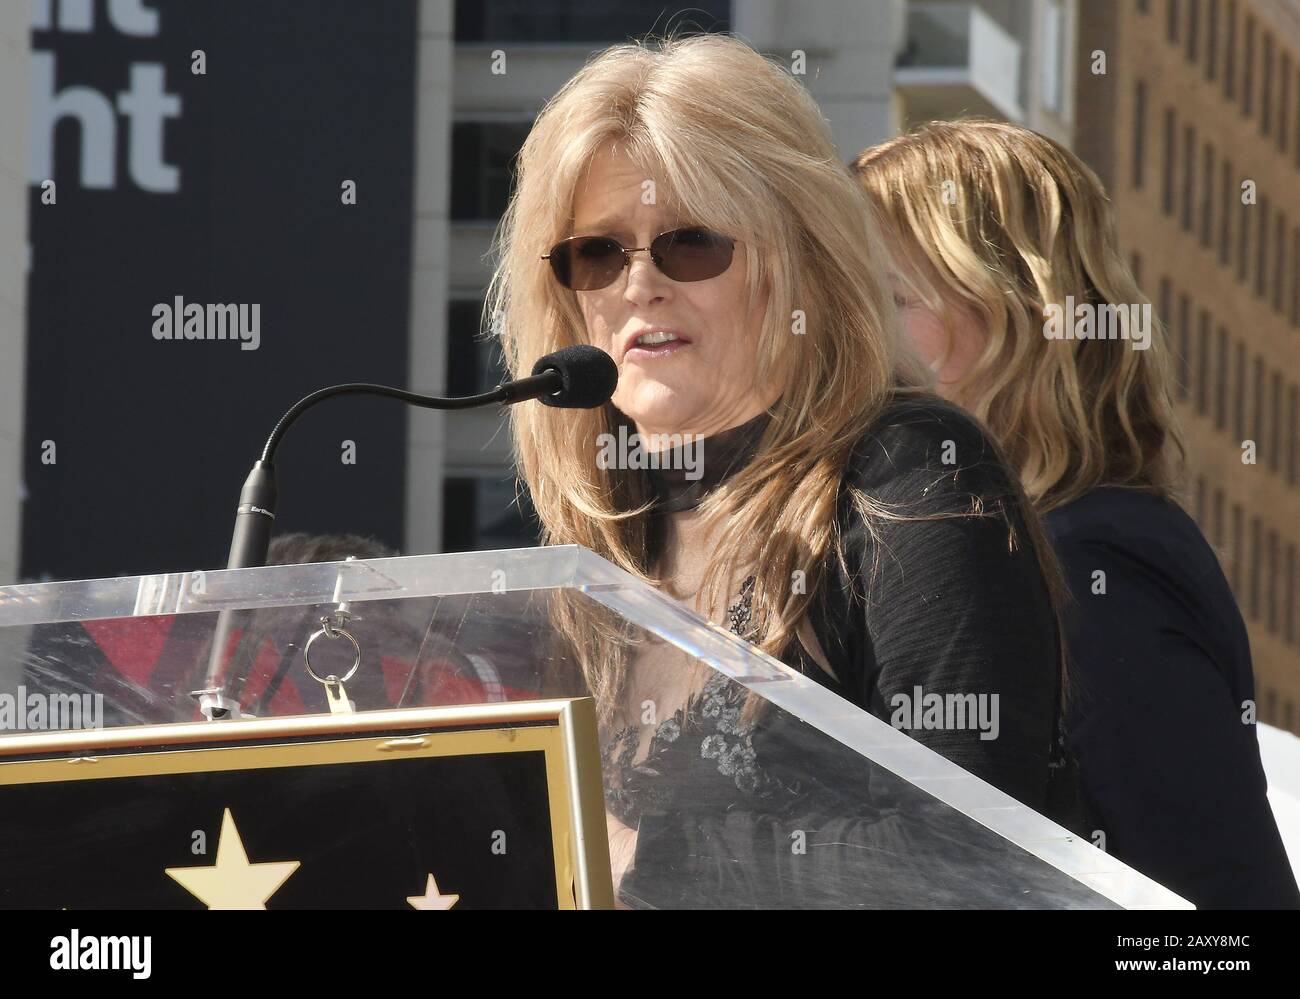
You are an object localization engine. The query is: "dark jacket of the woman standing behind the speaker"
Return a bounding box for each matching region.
[1047,489,1300,908]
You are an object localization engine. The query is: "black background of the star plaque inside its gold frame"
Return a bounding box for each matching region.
[0,734,572,911]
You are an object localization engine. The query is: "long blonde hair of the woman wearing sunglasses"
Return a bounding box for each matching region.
[485,35,928,709]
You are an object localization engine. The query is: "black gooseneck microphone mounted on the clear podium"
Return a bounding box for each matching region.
[191,343,619,721]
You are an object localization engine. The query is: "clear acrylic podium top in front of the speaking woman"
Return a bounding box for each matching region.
[0,546,1191,908]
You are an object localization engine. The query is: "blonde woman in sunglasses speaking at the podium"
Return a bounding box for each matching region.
[486,35,1069,905]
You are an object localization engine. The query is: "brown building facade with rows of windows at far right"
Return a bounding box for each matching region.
[1075,0,1300,732]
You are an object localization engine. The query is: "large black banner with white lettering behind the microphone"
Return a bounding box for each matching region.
[21,0,416,579]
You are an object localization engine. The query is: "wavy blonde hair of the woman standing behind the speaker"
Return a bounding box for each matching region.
[853,121,1183,513]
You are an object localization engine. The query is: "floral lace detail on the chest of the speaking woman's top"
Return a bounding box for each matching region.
[601,576,797,826]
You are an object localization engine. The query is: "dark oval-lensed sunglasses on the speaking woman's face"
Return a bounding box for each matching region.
[542,226,736,291]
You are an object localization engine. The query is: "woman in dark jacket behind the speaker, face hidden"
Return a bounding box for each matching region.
[853,122,1300,907]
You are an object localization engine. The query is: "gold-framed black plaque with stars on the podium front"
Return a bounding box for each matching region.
[0,697,614,911]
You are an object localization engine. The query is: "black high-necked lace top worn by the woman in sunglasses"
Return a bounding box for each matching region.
[603,398,1078,907]
